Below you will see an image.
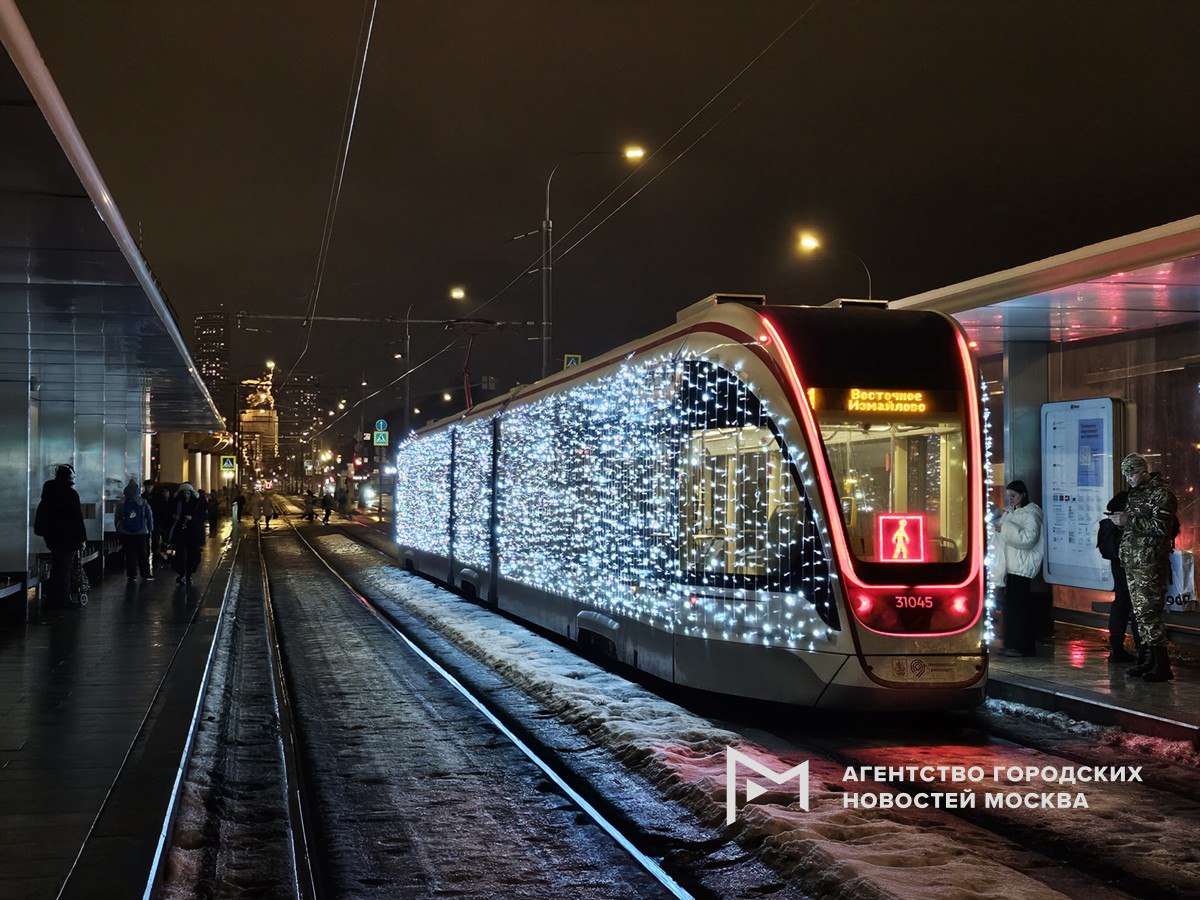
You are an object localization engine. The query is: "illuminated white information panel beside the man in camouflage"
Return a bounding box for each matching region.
[1042,397,1122,590]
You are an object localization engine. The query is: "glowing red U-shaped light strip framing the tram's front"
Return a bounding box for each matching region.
[760,316,983,631]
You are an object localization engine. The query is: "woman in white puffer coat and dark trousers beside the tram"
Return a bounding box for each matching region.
[996,481,1045,656]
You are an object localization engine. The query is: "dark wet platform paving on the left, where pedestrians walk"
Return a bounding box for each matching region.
[0,521,230,898]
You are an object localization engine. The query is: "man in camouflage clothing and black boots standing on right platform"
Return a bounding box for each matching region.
[1109,454,1180,682]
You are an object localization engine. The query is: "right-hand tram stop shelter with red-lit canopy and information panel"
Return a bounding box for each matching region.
[892,216,1200,642]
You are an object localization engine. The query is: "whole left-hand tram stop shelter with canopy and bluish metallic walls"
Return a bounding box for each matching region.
[0,4,224,618]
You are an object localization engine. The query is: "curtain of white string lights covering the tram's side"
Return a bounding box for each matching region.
[396,354,840,649]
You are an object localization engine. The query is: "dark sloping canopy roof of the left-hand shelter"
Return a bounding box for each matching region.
[0,10,223,431]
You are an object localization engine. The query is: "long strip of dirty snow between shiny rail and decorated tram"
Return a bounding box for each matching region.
[318,535,1060,900]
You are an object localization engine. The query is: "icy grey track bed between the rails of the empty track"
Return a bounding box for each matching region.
[264,532,661,900]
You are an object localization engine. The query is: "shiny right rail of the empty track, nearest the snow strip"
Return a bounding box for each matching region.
[264,515,707,900]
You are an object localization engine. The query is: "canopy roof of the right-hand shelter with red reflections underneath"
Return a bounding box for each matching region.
[892,216,1200,355]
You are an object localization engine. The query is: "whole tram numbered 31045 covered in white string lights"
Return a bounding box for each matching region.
[395,295,988,709]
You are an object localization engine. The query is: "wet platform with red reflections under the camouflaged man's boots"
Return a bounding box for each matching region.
[988,622,1200,746]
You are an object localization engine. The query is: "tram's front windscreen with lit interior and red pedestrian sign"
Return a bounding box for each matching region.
[821,414,968,563]
